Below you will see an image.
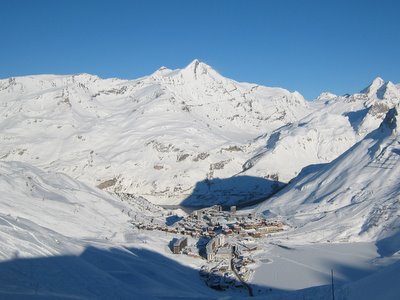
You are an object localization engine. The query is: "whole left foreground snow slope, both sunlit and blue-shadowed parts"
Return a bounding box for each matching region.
[0,162,217,299]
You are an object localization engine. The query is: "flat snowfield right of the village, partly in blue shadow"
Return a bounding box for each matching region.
[252,239,400,299]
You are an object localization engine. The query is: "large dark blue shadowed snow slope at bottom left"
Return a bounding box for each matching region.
[0,247,220,299]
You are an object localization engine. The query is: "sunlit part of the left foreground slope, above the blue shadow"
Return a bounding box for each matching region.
[0,162,145,259]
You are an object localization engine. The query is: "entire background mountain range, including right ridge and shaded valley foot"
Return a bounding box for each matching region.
[0,60,399,205]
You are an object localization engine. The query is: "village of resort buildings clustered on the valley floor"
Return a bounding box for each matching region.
[132,205,284,290]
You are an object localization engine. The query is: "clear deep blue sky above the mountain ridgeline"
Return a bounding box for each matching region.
[0,0,400,99]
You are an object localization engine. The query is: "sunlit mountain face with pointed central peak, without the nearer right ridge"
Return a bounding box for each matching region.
[0,60,309,204]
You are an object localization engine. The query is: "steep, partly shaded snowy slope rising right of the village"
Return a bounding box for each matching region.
[257,106,400,246]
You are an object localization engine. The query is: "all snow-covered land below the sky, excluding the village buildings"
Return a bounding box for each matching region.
[0,60,400,299]
